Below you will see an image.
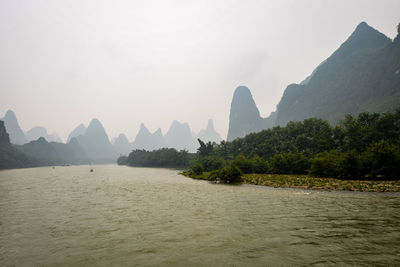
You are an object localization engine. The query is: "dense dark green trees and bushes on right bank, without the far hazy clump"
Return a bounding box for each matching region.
[184,109,400,187]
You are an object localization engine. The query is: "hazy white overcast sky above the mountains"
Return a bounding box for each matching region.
[0,0,400,141]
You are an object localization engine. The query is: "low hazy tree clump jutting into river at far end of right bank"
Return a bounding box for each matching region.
[127,148,191,167]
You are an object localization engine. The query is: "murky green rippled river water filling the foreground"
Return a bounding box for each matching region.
[0,165,400,266]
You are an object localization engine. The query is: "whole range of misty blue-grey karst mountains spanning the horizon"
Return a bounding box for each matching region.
[1,22,400,168]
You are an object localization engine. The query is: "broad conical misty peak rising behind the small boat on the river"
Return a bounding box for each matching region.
[75,119,118,162]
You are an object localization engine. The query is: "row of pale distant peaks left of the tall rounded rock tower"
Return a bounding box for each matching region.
[2,110,222,164]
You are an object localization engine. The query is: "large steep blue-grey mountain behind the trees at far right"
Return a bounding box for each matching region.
[275,22,400,125]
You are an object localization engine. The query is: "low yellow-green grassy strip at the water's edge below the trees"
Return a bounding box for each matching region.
[181,172,400,192]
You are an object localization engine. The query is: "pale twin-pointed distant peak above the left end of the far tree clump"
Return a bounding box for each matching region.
[133,123,165,151]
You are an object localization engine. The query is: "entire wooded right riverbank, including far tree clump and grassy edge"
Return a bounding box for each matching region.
[119,109,400,191]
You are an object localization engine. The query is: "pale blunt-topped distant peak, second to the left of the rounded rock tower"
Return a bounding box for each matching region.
[165,120,197,152]
